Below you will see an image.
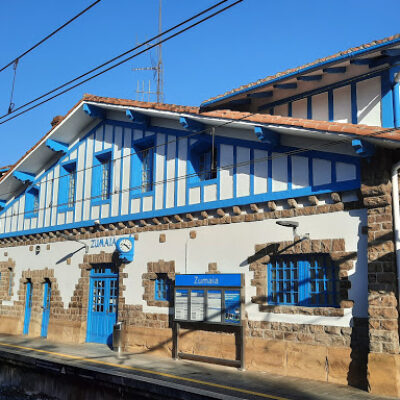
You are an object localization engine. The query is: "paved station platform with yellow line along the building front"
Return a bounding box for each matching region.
[0,335,390,400]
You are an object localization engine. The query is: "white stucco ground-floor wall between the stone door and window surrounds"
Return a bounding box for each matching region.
[0,210,368,326]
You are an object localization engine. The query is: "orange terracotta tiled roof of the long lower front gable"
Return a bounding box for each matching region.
[0,94,400,187]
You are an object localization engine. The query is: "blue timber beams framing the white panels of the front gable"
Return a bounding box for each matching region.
[0,117,360,237]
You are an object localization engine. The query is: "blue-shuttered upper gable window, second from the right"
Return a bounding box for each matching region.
[131,135,155,196]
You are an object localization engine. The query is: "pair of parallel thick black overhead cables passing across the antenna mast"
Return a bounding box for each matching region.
[0,0,244,125]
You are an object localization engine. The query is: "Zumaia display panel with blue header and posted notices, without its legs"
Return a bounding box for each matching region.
[175,274,244,325]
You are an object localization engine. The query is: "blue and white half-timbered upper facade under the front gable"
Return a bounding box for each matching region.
[0,103,360,238]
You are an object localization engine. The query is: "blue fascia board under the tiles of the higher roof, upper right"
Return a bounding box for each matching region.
[201,38,400,108]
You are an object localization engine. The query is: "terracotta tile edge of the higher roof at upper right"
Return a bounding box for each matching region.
[202,34,400,105]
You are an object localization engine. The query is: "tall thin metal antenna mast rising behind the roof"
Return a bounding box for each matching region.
[133,0,164,103]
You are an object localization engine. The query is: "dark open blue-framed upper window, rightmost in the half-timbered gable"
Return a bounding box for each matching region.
[189,139,218,183]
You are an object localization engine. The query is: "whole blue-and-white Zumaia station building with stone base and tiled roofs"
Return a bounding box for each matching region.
[0,35,400,396]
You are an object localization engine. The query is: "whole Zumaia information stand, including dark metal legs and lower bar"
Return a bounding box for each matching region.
[173,274,245,370]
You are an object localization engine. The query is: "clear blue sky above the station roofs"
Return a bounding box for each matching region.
[0,0,400,165]
